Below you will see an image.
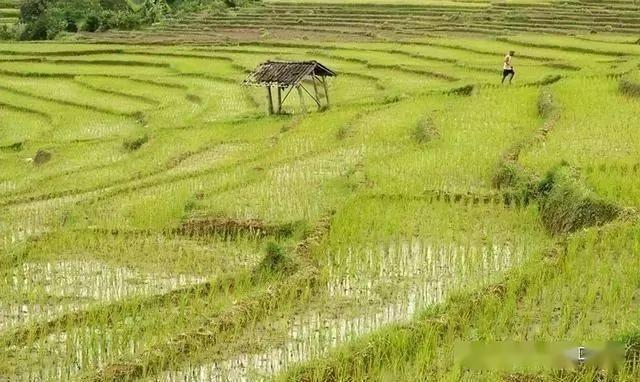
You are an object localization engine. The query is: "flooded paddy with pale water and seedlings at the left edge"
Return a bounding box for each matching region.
[0,261,206,330]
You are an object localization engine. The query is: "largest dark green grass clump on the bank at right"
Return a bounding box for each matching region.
[538,163,622,234]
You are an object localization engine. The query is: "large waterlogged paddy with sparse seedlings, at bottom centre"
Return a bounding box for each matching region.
[155,241,524,382]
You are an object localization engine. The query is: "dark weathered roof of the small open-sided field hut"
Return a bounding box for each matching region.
[244,61,336,87]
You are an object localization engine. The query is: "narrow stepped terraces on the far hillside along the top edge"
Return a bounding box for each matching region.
[89,0,640,42]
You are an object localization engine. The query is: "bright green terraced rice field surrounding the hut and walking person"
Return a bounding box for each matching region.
[0,31,640,381]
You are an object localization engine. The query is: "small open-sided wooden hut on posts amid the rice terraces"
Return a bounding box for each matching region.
[244,61,336,114]
